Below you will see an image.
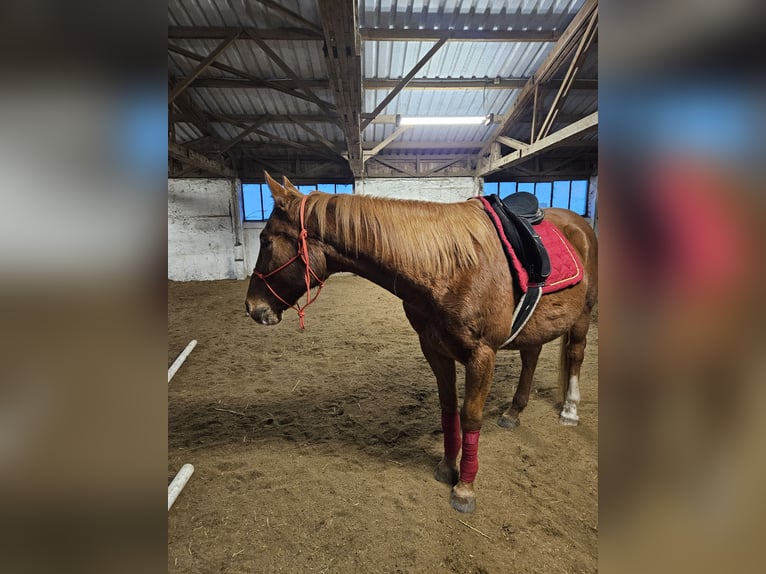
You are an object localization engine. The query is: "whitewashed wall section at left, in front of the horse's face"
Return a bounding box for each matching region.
[168,179,246,281]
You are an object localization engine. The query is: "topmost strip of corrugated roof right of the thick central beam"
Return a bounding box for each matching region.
[359,0,584,30]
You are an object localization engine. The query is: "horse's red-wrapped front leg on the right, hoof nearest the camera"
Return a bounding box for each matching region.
[450,346,495,512]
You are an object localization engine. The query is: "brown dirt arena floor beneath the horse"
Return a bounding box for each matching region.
[168,276,598,574]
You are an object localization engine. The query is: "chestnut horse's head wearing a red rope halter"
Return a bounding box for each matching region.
[245,172,327,326]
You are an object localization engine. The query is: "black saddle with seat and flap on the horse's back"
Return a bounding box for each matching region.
[485,195,551,284]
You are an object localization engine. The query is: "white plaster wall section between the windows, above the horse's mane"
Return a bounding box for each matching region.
[356,177,481,203]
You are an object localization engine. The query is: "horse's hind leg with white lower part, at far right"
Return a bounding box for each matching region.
[559,308,591,426]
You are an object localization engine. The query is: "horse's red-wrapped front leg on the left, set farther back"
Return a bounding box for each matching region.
[419,333,460,485]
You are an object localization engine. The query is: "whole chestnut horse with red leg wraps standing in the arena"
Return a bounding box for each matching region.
[245,173,597,512]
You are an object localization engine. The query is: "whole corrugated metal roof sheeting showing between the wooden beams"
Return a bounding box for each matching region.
[168,0,598,180]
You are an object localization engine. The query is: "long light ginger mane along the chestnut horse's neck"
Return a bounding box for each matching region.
[306,192,496,275]
